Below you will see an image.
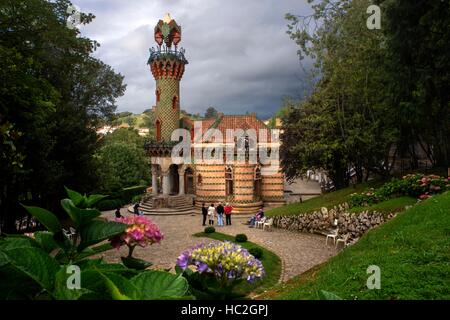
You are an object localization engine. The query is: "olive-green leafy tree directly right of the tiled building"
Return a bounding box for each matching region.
[281,0,397,188]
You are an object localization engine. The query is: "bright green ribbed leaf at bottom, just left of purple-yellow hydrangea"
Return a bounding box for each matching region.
[131,270,188,299]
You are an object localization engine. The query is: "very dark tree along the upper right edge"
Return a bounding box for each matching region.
[378,0,450,167]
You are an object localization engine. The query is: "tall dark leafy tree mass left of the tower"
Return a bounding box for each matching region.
[0,0,125,232]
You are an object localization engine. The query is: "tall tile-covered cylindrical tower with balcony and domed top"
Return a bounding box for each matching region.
[148,14,188,141]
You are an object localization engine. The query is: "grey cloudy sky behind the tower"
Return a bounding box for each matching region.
[73,0,310,118]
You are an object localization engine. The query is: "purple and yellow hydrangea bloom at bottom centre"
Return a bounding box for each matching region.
[177,241,265,299]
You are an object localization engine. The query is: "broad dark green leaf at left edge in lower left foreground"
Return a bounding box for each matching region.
[3,248,59,291]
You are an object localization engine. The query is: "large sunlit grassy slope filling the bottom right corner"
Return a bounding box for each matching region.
[265,192,450,299]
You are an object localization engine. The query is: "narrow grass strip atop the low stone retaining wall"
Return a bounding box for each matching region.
[266,180,384,216]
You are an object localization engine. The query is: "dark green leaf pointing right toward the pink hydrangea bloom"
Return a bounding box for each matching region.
[77,220,128,252]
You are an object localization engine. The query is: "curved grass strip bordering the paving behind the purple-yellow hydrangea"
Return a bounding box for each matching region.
[194,232,281,295]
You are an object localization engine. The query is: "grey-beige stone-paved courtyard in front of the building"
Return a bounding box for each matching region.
[102,208,337,282]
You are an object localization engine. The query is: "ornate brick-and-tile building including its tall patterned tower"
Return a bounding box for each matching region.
[146,15,284,213]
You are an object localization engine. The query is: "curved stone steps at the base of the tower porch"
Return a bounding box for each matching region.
[131,195,199,215]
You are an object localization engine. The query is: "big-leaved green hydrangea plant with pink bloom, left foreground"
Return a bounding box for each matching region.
[0,190,188,300]
